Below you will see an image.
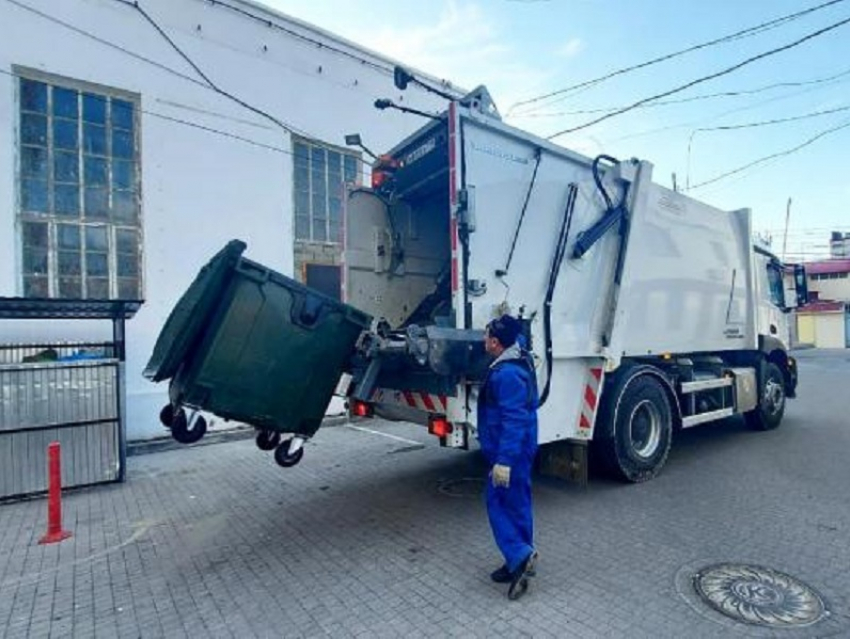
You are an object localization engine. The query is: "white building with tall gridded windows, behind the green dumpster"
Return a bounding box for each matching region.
[0,0,464,439]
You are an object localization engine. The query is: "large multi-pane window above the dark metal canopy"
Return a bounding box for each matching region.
[16,69,142,299]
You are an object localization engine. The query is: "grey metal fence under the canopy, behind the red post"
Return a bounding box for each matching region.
[0,343,122,499]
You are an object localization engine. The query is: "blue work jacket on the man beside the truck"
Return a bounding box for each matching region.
[478,347,538,467]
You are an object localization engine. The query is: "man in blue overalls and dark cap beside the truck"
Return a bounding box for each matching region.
[478,315,538,599]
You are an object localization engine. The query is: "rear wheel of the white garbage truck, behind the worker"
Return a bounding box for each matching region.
[600,373,673,483]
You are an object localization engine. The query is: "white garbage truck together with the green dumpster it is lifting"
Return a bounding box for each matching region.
[146,89,807,482]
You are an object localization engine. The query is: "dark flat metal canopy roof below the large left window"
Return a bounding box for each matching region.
[0,297,143,321]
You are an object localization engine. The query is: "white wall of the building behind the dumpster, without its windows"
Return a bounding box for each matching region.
[0,0,458,439]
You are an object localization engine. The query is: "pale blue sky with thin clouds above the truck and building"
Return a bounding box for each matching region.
[264,0,850,258]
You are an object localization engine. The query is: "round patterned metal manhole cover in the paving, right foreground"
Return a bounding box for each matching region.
[694,564,826,628]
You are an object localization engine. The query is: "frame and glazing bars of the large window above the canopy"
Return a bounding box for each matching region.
[12,65,145,299]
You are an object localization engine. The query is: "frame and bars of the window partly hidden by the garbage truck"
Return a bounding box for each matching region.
[292,135,363,246]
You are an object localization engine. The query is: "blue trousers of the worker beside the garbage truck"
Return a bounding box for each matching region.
[486,464,534,572]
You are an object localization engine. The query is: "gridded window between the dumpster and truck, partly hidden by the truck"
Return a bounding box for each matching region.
[293,139,360,244]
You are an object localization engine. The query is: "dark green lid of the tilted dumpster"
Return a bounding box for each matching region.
[142,240,247,382]
